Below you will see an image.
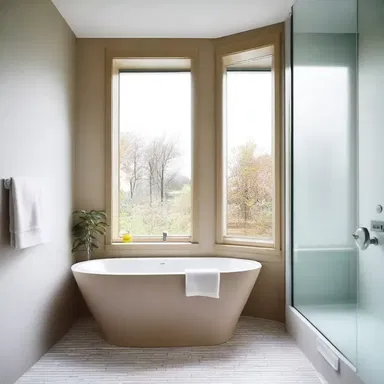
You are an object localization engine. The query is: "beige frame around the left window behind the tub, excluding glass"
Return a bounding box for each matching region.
[105,48,199,246]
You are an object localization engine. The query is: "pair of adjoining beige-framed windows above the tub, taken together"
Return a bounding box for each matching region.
[106,24,284,261]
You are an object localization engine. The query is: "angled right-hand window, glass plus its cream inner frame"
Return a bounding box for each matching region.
[217,46,281,249]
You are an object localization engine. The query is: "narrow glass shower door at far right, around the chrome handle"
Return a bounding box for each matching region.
[357,0,384,384]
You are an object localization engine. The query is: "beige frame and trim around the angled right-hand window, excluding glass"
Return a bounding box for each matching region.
[215,24,283,256]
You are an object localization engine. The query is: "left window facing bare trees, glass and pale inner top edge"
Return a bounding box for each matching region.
[112,59,193,243]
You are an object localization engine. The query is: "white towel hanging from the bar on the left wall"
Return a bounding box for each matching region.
[9,177,44,249]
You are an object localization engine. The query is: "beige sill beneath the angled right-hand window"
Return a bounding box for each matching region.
[215,244,283,262]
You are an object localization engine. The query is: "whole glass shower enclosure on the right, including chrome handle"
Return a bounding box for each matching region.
[290,0,384,384]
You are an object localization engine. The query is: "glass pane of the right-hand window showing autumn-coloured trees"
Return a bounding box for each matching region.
[226,68,273,241]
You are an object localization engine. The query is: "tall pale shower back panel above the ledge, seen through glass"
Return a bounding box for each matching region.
[294,34,356,248]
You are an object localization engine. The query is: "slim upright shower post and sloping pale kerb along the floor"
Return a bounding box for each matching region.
[283,11,363,384]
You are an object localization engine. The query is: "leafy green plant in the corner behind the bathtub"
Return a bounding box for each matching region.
[72,210,108,260]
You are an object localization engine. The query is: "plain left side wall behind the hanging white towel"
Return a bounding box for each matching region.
[0,0,78,384]
